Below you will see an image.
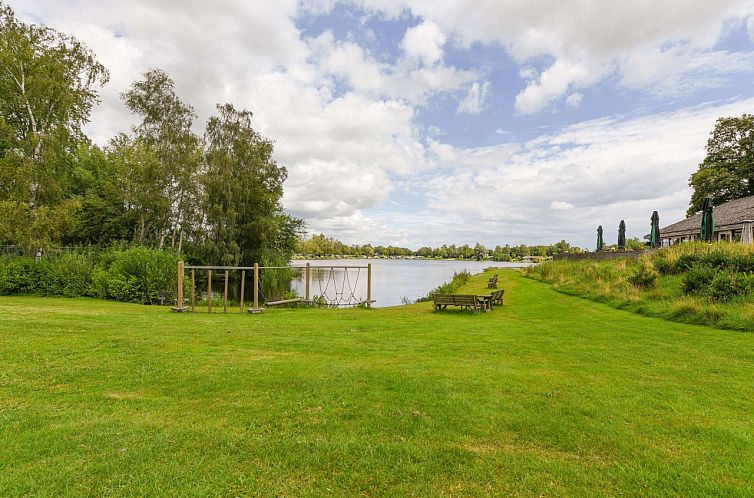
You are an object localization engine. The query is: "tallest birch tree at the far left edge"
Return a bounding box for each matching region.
[0,2,108,251]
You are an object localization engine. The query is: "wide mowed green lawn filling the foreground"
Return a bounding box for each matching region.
[0,271,754,496]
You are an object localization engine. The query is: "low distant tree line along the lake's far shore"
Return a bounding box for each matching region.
[296,234,582,261]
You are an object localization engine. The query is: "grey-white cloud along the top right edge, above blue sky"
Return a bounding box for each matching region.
[352,0,754,114]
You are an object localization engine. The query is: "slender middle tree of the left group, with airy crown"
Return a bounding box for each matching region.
[122,69,202,251]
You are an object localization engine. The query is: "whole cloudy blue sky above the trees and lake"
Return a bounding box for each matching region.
[8,0,754,248]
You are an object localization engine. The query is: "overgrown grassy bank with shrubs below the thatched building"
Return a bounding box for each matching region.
[524,243,754,331]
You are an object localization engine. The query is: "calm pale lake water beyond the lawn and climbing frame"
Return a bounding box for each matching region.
[292,259,529,307]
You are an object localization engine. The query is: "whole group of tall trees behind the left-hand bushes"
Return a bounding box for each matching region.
[0,2,303,265]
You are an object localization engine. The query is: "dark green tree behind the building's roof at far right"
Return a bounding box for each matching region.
[686,114,754,216]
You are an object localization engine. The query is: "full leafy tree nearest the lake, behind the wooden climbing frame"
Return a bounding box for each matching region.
[204,104,302,264]
